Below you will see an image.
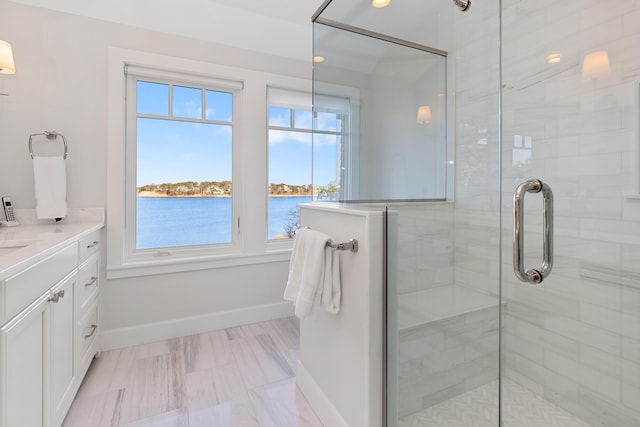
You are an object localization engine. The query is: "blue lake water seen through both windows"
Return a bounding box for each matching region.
[136,196,311,249]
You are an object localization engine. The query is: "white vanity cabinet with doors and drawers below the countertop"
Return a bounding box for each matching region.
[0,224,101,427]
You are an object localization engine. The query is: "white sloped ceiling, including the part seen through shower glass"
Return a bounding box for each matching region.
[9,0,454,66]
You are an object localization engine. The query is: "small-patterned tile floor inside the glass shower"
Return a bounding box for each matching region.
[398,380,592,427]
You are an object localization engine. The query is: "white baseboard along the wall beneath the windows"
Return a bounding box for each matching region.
[100,301,293,351]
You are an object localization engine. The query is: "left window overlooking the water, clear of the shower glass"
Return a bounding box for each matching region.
[127,69,235,251]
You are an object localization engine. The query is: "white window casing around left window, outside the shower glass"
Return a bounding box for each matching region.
[106,47,311,278]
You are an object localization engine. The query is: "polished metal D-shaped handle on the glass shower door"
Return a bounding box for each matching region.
[513,179,553,285]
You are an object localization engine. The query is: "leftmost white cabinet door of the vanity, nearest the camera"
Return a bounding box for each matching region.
[0,297,49,427]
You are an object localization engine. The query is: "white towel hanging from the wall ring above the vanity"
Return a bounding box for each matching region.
[33,156,67,219]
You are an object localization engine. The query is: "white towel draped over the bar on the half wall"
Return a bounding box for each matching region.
[284,229,340,319]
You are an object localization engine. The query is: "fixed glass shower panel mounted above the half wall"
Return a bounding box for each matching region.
[314,19,450,201]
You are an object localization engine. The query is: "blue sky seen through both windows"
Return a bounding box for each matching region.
[137,82,336,186]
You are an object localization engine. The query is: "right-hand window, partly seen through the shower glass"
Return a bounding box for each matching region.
[268,87,350,240]
